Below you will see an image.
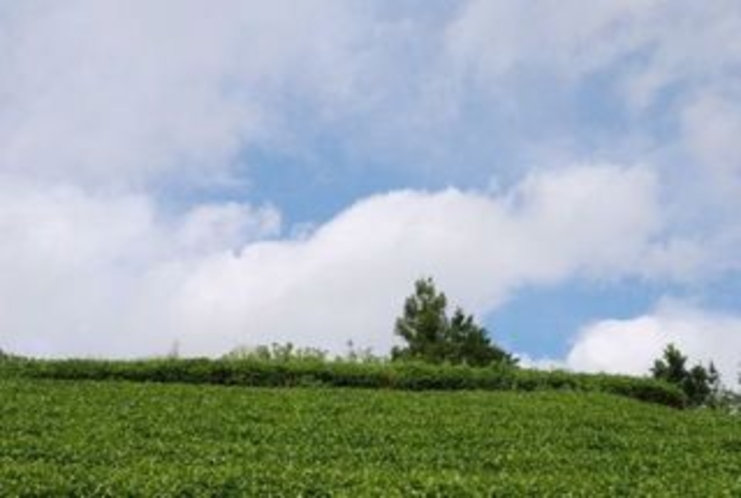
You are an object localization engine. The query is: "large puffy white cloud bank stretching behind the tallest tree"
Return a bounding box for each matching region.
[0,166,658,355]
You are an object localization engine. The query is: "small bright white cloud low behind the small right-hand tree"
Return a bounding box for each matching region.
[566,300,741,387]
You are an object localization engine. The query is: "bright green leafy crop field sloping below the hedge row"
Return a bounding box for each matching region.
[0,378,741,496]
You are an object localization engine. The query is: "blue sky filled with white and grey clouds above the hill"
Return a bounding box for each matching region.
[0,0,741,383]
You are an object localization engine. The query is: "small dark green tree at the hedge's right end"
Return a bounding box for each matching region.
[651,344,721,406]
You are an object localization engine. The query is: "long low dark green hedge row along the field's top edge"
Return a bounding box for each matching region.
[0,358,686,408]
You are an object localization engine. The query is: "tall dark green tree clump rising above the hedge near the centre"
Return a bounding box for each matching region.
[391,278,516,366]
